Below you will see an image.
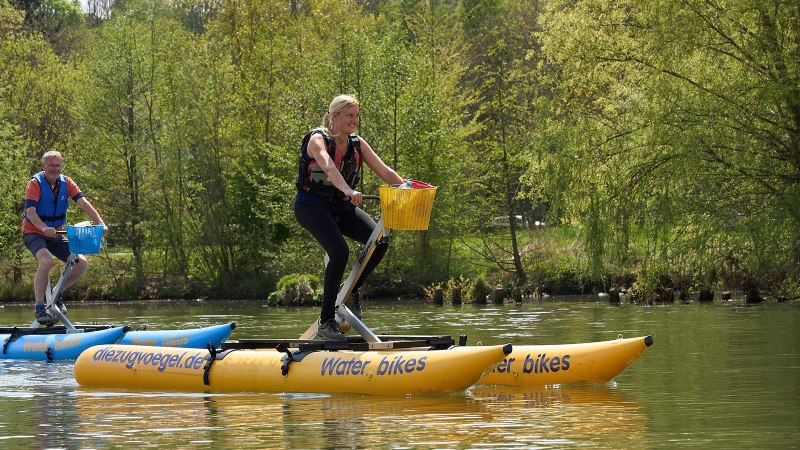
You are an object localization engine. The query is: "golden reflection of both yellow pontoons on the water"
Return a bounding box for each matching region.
[69,386,646,448]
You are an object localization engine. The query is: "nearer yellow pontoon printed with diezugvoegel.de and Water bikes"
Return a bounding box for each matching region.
[75,345,511,395]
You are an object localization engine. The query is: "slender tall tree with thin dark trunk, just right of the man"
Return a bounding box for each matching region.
[79,3,159,290]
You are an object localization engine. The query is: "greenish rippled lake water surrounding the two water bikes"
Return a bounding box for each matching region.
[0,301,800,449]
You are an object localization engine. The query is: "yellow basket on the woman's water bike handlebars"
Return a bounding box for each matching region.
[378,180,436,230]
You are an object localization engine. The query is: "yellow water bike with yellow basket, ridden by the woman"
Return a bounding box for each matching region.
[75,182,652,395]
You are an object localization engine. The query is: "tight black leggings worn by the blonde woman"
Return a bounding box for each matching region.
[294,203,389,322]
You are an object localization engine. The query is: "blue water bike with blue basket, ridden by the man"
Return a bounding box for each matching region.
[0,222,236,361]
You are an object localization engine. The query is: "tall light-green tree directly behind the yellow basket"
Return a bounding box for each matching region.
[390,2,477,280]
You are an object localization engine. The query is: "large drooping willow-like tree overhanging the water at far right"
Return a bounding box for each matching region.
[536,0,800,296]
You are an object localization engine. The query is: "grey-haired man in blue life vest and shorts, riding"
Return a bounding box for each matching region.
[22,151,108,324]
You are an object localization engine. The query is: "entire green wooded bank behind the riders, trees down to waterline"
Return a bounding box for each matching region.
[0,0,800,304]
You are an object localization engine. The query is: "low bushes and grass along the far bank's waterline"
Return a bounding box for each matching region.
[0,225,800,306]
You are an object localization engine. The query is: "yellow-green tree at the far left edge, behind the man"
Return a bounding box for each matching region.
[0,0,74,282]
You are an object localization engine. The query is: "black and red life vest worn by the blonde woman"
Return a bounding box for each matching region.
[296,130,361,203]
